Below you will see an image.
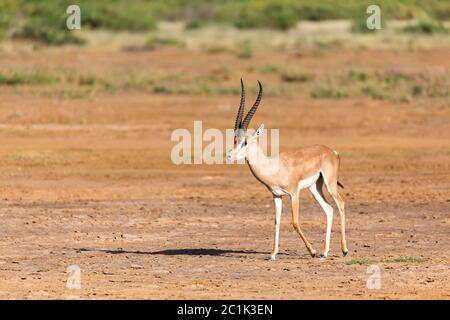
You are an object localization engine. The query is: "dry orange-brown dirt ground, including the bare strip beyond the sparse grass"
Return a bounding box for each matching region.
[0,43,450,299]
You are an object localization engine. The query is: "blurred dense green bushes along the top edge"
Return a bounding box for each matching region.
[0,0,450,44]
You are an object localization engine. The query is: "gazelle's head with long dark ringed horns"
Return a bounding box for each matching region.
[227,79,264,161]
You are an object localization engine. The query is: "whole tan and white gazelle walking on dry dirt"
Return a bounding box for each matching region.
[227,79,348,260]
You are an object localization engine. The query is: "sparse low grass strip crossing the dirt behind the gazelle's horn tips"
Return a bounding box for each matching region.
[0,65,450,103]
